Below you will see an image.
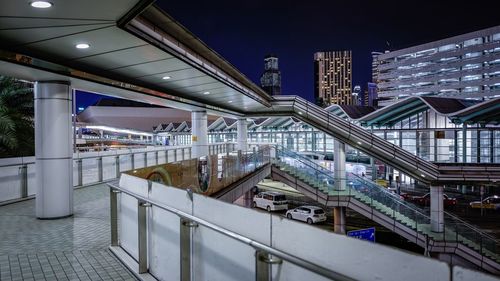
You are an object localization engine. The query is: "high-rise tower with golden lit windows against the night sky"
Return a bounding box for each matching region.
[314,51,353,106]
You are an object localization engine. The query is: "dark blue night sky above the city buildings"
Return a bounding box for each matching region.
[78,0,500,107]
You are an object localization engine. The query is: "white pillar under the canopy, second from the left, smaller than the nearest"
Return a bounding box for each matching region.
[191,111,208,158]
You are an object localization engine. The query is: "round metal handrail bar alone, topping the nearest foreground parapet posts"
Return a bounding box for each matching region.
[108,183,355,281]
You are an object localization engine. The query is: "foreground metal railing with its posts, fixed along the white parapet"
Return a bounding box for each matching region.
[108,183,355,281]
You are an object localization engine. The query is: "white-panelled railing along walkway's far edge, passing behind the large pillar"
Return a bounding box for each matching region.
[0,143,235,204]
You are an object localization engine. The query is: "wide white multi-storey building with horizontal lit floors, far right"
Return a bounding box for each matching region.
[373,26,500,105]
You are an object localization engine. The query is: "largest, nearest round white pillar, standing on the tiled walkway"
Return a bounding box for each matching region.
[35,81,73,219]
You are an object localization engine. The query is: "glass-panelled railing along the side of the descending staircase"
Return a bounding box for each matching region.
[273,146,500,262]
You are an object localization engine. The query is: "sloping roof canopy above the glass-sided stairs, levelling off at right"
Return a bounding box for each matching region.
[247,96,500,185]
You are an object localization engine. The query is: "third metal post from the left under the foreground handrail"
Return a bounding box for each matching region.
[180,219,198,281]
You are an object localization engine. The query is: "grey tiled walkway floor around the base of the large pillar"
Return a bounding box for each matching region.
[0,184,136,281]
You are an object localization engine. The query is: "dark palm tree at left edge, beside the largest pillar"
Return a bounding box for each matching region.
[0,76,35,157]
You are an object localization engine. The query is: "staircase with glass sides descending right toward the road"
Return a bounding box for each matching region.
[271,146,500,274]
